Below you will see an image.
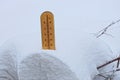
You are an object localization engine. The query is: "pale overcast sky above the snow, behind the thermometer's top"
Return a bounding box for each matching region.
[0,0,120,44]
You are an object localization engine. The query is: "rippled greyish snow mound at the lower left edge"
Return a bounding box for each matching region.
[0,46,18,80]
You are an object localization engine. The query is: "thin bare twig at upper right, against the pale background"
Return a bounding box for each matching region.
[96,19,120,38]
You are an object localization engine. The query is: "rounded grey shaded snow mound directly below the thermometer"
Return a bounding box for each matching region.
[19,53,78,80]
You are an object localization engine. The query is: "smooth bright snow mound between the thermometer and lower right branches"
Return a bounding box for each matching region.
[51,31,113,80]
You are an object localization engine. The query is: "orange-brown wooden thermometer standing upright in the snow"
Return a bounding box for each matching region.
[40,11,55,50]
